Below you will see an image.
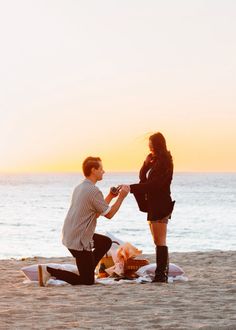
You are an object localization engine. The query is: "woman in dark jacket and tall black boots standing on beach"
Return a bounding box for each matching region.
[130,132,175,283]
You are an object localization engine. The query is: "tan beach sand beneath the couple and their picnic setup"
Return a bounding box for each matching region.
[0,251,236,330]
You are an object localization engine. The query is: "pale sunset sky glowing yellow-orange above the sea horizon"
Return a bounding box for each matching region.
[0,0,236,173]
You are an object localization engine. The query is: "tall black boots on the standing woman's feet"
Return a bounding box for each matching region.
[152,245,169,283]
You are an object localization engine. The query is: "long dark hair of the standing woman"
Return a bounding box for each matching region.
[149,132,173,168]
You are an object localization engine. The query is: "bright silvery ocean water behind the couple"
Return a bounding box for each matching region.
[0,173,236,259]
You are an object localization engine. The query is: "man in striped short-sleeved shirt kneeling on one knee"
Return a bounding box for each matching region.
[39,157,129,286]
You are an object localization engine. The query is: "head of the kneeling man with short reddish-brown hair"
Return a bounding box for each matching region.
[83,157,105,181]
